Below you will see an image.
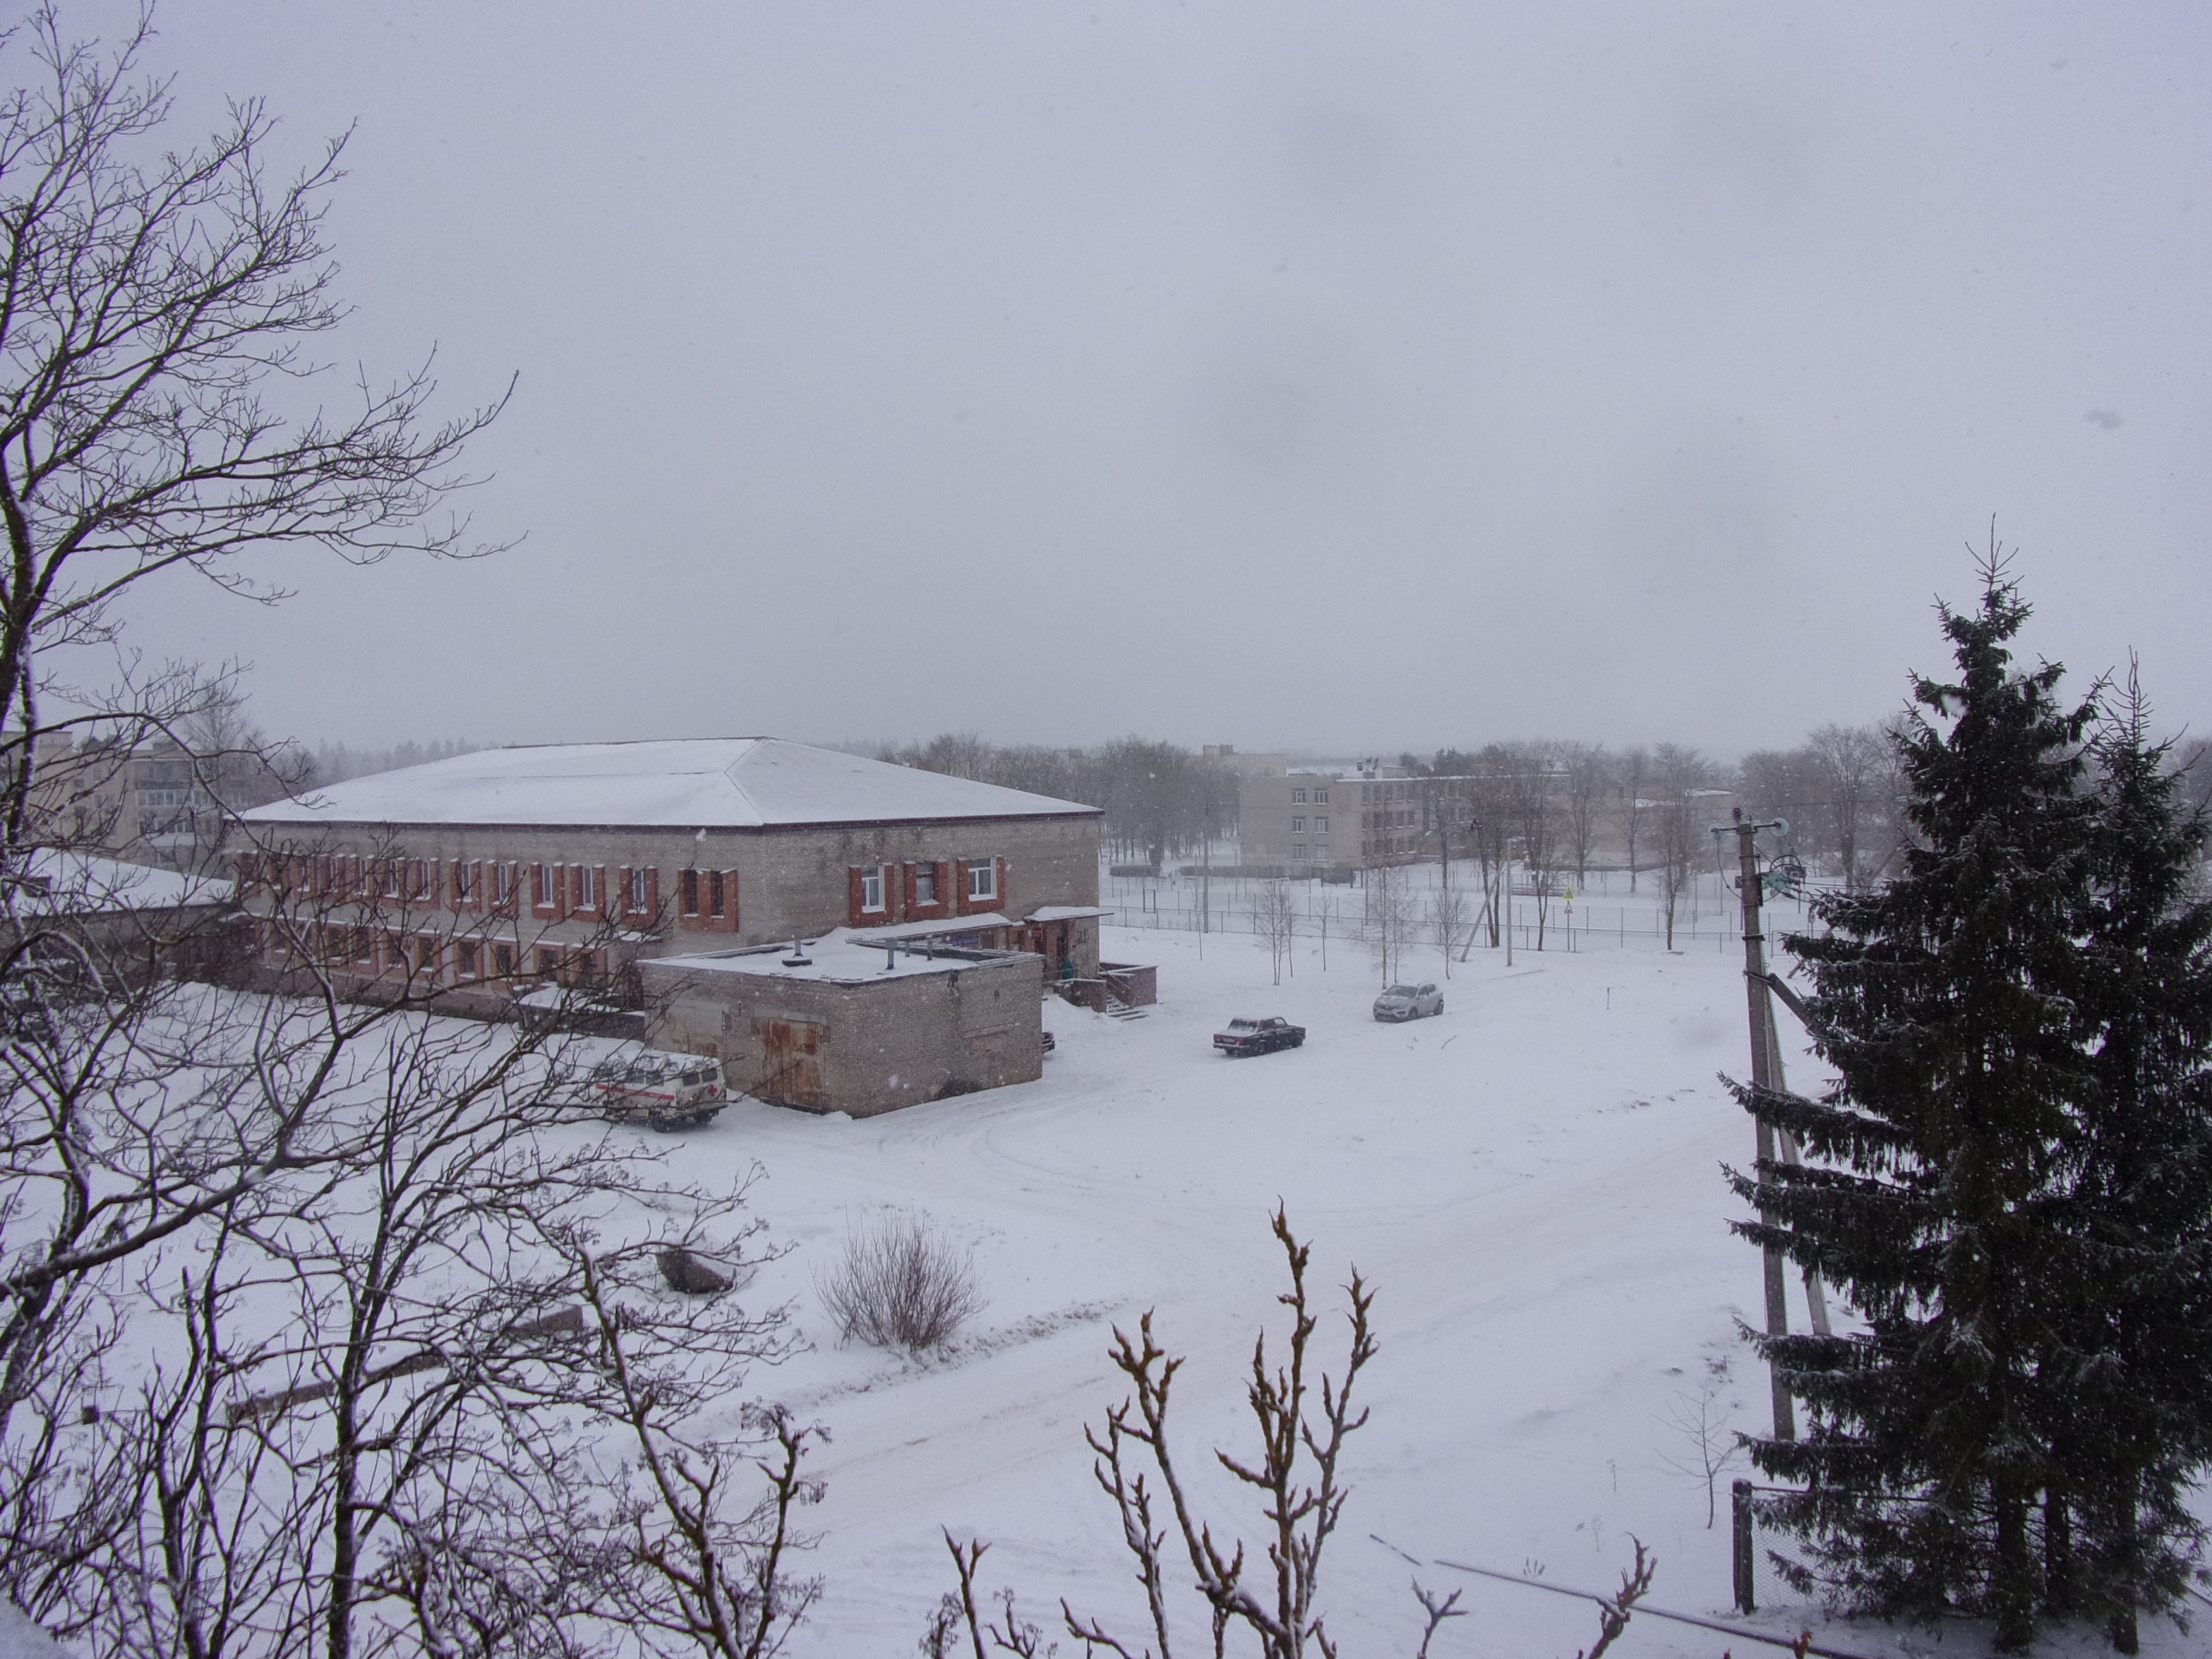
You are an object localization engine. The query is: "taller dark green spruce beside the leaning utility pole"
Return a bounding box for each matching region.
[1732,562,2097,1648]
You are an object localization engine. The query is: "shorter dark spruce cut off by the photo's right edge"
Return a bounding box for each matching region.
[2039,673,2212,1653]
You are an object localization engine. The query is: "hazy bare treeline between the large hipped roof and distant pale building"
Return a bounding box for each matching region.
[876,732,1237,865]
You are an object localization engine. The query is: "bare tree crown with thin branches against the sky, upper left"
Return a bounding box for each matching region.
[0,5,498,862]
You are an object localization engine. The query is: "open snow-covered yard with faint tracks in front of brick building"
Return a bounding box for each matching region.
[646,929,2201,1659]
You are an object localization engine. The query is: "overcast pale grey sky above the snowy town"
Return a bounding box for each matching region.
[99,0,2212,750]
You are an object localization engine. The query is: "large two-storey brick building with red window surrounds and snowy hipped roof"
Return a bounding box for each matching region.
[239,737,1102,1013]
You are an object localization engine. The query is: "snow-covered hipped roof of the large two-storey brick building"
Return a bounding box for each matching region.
[241,737,1097,830]
